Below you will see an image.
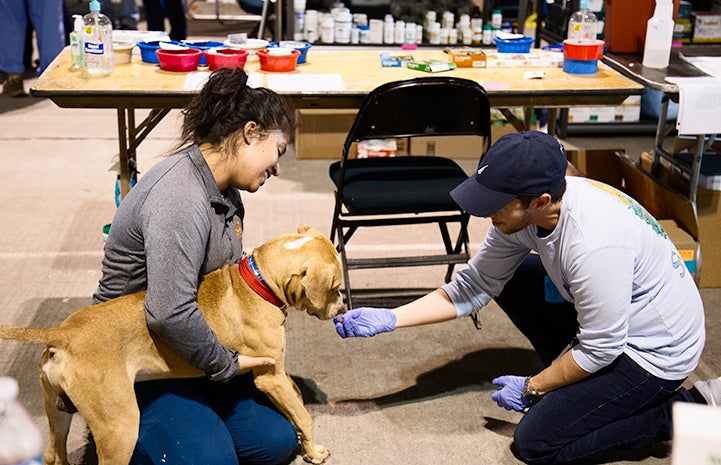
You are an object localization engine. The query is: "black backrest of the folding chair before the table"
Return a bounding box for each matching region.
[343,76,491,158]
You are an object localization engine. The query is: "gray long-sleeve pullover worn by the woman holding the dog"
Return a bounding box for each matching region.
[93,145,244,381]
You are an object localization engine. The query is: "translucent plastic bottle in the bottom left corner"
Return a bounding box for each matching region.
[0,377,43,465]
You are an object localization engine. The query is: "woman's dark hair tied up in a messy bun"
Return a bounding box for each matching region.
[181,68,296,150]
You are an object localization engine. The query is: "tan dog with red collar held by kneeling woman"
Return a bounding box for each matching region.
[0,227,344,465]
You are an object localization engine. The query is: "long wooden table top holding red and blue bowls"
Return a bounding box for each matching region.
[31,47,643,108]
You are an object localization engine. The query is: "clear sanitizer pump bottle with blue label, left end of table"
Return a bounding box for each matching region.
[83,0,115,75]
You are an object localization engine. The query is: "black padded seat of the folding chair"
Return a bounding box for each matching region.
[329,156,468,214]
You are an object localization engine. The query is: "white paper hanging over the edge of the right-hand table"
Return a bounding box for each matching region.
[666,76,721,135]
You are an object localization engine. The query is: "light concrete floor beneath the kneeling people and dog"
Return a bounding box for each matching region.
[0,11,721,465]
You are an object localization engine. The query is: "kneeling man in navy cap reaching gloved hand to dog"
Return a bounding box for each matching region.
[335,131,721,463]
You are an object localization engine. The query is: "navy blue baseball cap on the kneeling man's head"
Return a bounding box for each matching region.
[451,131,568,217]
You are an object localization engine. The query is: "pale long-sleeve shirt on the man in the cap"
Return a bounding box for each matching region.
[443,177,705,380]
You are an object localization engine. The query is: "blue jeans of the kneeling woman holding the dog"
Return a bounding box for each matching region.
[130,374,298,465]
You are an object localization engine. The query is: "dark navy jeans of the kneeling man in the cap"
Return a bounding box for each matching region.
[496,255,694,464]
